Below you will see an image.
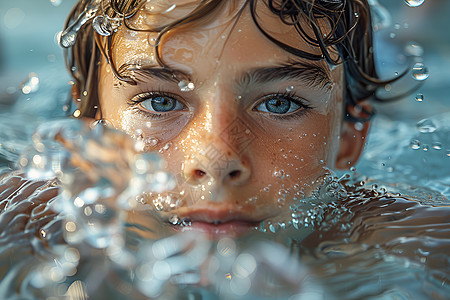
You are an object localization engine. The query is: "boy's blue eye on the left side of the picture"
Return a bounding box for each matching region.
[131,93,186,113]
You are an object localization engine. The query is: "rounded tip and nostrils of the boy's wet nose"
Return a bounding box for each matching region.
[184,144,251,186]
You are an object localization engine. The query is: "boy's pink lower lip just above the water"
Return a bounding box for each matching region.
[177,221,256,237]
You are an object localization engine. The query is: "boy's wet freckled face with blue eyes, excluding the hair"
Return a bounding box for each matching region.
[99,1,363,231]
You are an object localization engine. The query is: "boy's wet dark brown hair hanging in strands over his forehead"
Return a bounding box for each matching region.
[65,0,394,121]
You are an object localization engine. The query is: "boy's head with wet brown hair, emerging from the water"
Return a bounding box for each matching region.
[61,1,381,237]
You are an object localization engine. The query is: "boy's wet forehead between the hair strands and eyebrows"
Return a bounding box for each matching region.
[113,0,332,73]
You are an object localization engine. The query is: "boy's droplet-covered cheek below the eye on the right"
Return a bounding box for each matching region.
[249,114,337,196]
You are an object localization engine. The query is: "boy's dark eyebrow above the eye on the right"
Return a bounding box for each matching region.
[239,61,331,88]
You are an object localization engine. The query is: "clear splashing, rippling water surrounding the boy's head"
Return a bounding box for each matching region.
[0,1,450,299]
